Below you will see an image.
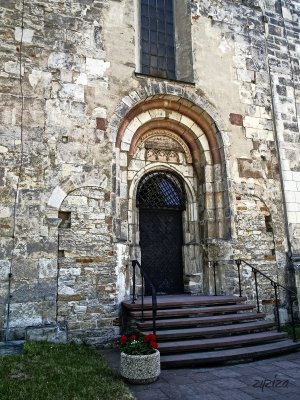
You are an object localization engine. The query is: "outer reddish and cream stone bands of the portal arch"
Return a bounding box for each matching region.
[116,95,231,238]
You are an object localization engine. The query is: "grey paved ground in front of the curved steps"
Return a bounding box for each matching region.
[103,350,300,400]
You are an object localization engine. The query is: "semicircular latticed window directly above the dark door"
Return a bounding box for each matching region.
[137,171,186,210]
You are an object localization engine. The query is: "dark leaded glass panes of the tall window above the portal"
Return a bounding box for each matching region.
[141,0,176,79]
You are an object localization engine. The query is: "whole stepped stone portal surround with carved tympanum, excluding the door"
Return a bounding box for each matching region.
[111,90,230,293]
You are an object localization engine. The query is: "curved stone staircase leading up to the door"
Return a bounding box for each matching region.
[123,295,300,368]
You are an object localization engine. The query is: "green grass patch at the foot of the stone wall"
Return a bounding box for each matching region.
[0,342,134,400]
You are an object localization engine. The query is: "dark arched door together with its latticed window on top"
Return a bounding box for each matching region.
[136,171,186,294]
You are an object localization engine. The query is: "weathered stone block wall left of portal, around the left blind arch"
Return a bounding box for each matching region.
[0,1,123,336]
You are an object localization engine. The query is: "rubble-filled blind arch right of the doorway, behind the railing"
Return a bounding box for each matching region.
[211,195,278,306]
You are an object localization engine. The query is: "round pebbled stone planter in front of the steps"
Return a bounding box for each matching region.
[120,350,160,384]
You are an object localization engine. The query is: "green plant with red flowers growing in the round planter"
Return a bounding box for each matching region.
[120,333,158,355]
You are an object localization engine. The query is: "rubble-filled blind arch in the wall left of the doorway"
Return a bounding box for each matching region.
[57,188,124,343]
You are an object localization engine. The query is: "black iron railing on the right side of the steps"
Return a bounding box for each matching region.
[209,259,297,342]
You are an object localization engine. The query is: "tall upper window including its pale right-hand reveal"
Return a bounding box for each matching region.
[137,0,194,82]
